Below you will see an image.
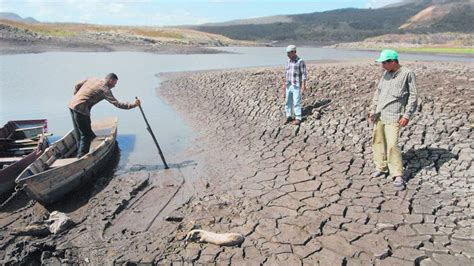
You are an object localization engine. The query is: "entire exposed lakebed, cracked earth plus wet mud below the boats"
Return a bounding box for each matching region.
[0,59,474,265]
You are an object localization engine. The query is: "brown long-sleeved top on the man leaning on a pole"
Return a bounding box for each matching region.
[69,78,133,116]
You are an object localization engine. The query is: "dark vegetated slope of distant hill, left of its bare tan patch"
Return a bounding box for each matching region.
[193,4,424,44]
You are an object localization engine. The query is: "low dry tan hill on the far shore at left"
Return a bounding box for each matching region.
[0,19,252,53]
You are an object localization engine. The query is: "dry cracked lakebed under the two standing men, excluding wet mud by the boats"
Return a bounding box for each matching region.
[157,62,474,265]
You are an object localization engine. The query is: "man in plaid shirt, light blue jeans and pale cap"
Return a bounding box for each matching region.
[282,45,307,125]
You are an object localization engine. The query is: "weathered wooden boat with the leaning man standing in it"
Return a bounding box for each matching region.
[16,118,117,205]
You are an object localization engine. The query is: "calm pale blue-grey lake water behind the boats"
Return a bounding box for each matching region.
[0,47,473,169]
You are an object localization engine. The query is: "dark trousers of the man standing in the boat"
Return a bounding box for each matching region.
[69,109,95,157]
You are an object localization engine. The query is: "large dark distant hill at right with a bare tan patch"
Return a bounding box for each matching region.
[192,0,474,44]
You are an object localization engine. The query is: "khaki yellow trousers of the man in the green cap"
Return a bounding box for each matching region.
[372,118,403,176]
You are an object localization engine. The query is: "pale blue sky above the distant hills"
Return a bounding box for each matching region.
[0,0,400,26]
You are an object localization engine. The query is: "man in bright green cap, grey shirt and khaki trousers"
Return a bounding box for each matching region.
[369,49,417,189]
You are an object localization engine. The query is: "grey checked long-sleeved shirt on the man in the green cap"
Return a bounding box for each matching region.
[370,67,417,124]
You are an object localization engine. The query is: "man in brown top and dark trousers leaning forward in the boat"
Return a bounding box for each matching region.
[69,73,140,158]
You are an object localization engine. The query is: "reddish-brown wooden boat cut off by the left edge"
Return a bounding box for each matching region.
[0,119,48,195]
